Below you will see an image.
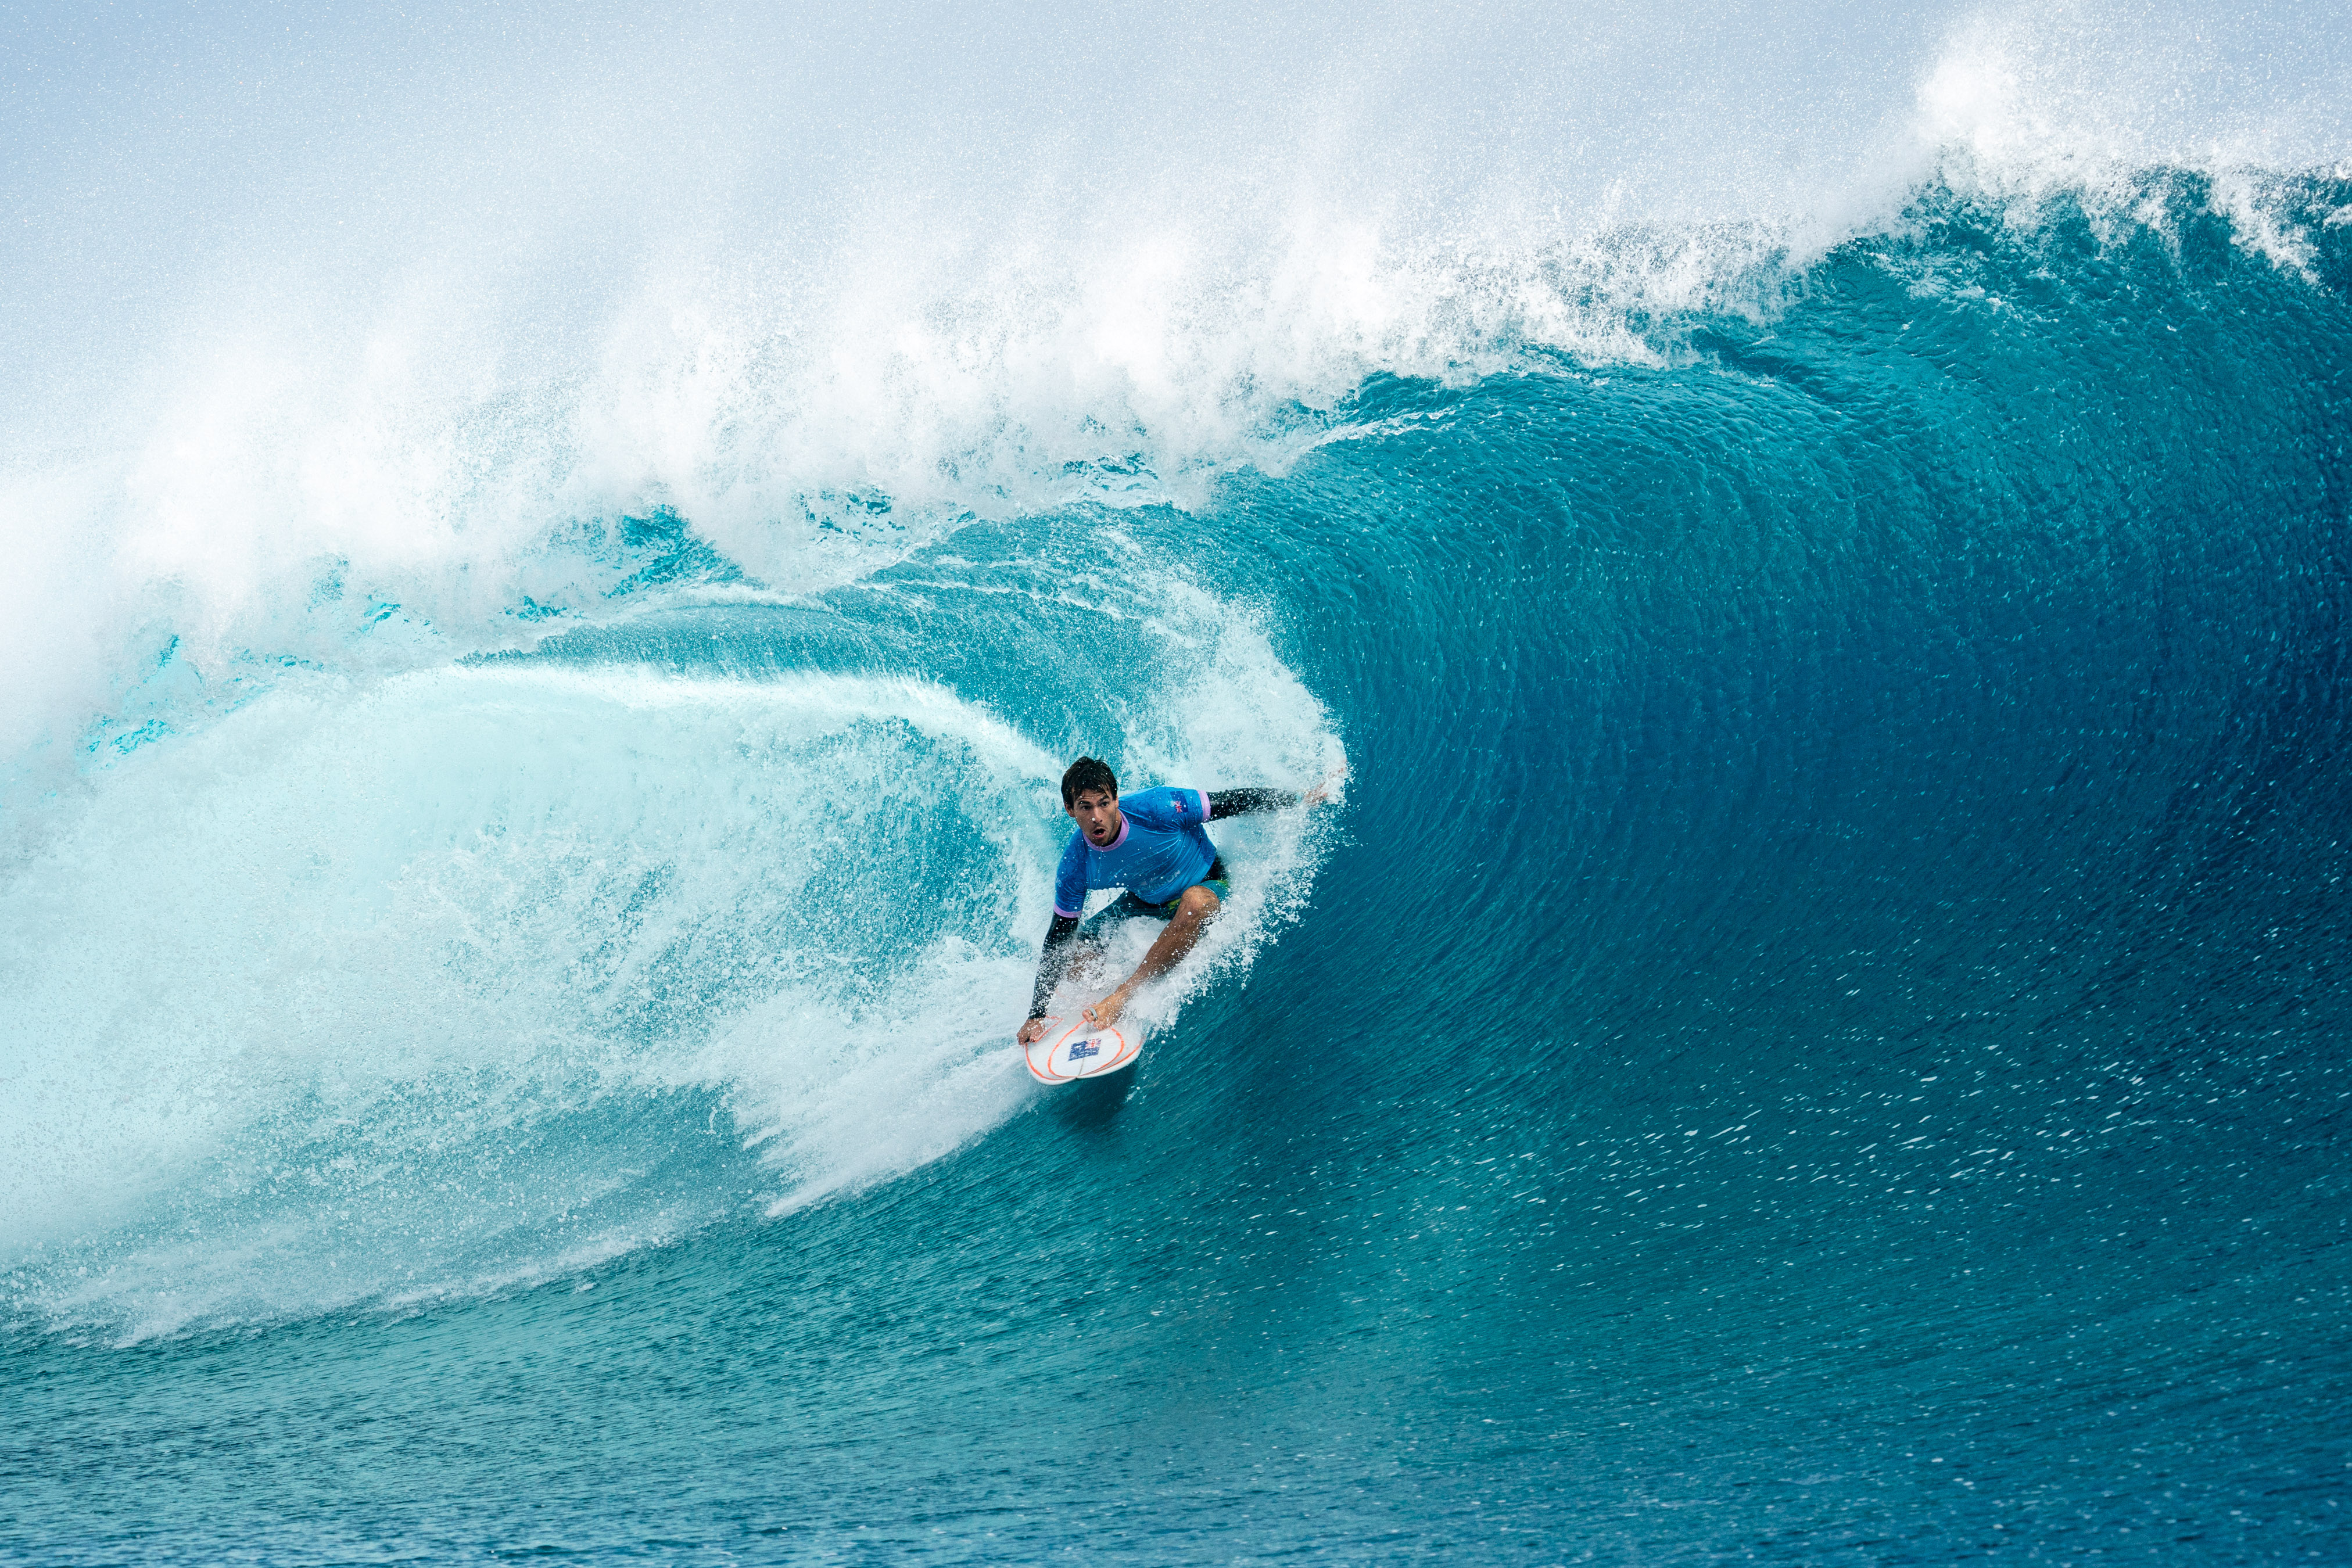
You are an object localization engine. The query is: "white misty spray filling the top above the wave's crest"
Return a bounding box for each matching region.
[0,2,2352,780]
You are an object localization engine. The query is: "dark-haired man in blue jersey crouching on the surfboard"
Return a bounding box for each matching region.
[1021,757,1338,1046]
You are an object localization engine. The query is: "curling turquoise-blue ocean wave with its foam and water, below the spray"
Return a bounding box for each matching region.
[13,176,2352,1563]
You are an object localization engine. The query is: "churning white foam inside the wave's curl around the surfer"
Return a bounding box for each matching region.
[0,580,1336,1337]
